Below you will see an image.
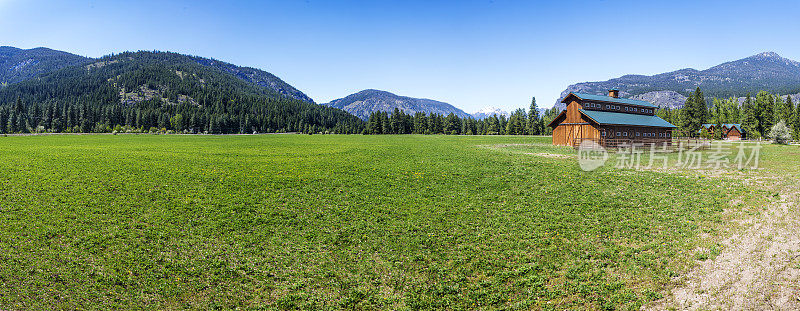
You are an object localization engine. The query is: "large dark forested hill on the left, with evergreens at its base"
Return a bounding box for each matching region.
[0,52,363,133]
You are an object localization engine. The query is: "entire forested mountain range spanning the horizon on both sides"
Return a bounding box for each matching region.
[0,46,800,128]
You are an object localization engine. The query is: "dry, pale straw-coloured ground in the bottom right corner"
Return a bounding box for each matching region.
[642,184,800,310]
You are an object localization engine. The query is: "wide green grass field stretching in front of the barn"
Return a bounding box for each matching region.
[0,135,788,310]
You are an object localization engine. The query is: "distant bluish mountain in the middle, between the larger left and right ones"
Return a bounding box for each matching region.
[324,89,470,120]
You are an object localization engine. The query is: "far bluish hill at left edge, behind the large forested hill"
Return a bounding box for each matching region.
[0,46,92,85]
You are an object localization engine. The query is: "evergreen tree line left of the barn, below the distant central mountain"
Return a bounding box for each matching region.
[363,97,561,135]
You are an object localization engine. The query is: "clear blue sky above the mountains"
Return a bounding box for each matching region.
[0,0,800,112]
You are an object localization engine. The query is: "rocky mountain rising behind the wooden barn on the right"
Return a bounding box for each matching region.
[556,52,800,108]
